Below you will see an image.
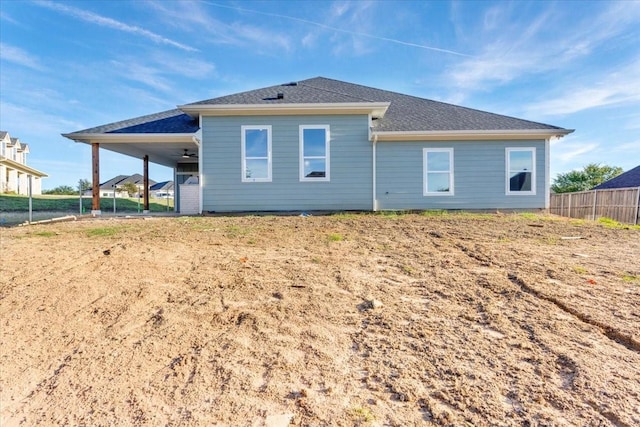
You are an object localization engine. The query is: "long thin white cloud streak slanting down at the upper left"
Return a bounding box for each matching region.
[35,1,198,52]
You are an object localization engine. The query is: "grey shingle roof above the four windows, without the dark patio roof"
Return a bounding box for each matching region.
[188,77,562,131]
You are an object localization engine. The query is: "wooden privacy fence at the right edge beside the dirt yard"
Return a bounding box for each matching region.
[549,187,640,225]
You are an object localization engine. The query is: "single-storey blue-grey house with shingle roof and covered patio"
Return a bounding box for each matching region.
[64,77,573,213]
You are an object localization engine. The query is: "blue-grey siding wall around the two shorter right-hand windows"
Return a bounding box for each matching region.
[376,140,545,209]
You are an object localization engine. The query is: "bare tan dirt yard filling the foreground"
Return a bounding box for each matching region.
[0,214,640,427]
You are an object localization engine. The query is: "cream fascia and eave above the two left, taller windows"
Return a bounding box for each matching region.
[178,102,391,117]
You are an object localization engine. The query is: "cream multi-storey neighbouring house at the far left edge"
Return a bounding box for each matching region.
[0,131,47,196]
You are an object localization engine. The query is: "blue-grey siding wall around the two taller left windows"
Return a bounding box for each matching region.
[200,115,373,212]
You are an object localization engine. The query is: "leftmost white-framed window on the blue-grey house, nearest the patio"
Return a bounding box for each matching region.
[242,126,271,182]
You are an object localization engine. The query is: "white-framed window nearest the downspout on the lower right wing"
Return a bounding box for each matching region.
[423,148,453,196]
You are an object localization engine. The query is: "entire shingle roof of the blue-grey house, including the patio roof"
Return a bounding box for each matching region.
[64,77,572,139]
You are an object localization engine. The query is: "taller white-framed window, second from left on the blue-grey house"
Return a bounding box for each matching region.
[300,125,329,181]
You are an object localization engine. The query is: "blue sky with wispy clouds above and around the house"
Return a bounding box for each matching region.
[0,0,640,188]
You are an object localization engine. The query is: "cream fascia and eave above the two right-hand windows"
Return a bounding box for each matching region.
[373,129,573,141]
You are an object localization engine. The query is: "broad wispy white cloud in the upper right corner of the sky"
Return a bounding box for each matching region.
[446,2,640,90]
